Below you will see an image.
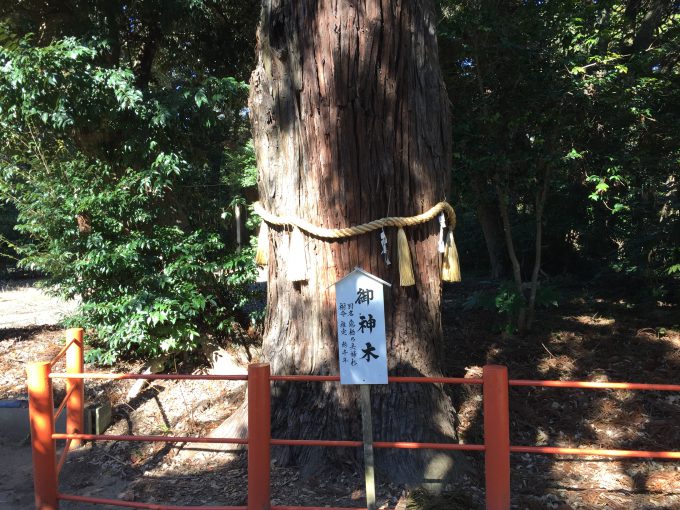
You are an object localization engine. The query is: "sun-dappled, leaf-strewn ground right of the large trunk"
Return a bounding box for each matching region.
[444,284,680,510]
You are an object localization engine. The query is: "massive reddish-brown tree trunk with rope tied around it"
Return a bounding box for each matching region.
[250,0,455,481]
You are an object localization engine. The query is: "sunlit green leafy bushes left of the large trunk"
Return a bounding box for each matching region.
[0,1,262,363]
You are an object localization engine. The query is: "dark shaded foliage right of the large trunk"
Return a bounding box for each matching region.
[440,0,680,299]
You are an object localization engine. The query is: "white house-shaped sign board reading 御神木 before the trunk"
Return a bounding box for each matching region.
[335,268,390,384]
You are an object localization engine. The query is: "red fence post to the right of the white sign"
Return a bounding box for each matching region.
[483,365,510,510]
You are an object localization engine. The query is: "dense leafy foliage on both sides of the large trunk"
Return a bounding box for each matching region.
[0,0,680,361]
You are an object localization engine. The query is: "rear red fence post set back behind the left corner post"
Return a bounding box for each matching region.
[66,328,85,448]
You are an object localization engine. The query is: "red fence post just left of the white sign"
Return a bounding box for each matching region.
[248,363,271,510]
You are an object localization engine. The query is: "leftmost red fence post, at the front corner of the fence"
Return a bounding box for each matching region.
[26,361,59,510]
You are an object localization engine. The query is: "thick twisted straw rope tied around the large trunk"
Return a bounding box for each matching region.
[253,202,456,239]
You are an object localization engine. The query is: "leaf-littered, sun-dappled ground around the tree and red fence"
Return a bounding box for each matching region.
[0,282,680,510]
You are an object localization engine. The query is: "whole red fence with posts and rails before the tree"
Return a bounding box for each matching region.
[27,329,680,510]
